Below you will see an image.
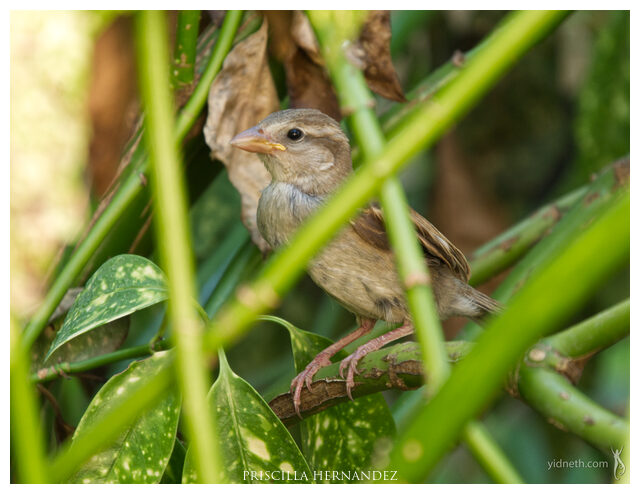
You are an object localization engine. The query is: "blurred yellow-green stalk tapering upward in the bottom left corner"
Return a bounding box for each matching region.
[9,317,49,484]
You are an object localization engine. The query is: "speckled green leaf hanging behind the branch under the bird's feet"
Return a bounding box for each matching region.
[263,316,395,482]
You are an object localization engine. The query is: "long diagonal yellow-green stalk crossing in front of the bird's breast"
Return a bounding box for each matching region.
[207,11,564,349]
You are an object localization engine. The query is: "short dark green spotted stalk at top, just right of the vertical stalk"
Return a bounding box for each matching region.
[172,10,200,87]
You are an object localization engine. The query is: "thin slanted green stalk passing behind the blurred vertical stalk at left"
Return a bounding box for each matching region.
[21,11,242,354]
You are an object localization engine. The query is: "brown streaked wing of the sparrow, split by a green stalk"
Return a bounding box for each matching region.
[351,203,470,282]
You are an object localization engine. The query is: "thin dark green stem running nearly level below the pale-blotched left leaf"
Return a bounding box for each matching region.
[31,340,169,383]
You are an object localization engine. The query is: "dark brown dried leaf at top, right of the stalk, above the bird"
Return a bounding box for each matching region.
[351,10,406,102]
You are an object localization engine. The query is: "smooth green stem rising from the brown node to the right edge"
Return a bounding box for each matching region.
[544,299,631,358]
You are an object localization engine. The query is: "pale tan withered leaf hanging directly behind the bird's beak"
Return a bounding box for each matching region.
[204,21,278,252]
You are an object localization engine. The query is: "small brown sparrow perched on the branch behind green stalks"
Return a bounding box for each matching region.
[231,109,500,416]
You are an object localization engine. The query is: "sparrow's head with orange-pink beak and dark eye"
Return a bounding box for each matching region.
[231,109,352,195]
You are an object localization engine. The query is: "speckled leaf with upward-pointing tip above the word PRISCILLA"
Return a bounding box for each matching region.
[182,351,313,484]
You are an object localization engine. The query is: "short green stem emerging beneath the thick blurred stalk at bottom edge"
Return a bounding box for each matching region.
[462,421,524,484]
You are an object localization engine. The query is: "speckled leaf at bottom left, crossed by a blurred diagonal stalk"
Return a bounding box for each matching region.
[69,352,180,484]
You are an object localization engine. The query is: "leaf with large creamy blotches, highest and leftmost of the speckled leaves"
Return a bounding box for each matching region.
[45,254,167,360]
